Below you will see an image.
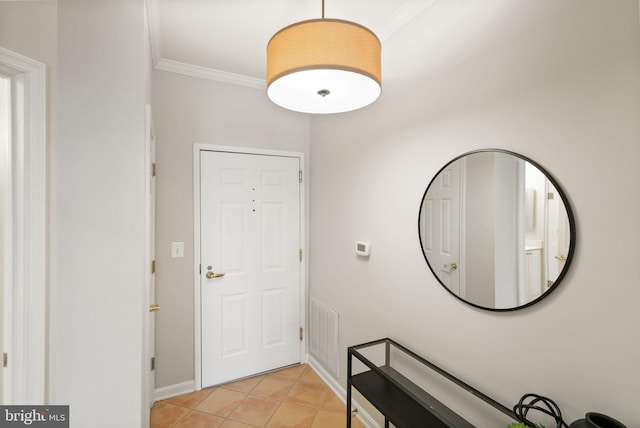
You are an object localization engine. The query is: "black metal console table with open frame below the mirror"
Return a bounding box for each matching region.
[347,338,516,428]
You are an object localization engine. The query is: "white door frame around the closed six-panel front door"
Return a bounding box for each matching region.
[193,144,308,391]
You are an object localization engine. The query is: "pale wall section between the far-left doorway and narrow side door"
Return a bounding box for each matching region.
[49,0,148,427]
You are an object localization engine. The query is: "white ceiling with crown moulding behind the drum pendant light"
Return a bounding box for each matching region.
[149,0,434,87]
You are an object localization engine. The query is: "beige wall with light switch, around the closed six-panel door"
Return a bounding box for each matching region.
[153,71,309,388]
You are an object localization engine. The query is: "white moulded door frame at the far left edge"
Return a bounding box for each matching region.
[0,47,47,404]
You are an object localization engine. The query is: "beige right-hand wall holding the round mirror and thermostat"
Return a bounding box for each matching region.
[309,0,640,427]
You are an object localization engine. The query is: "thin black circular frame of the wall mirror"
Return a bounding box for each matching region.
[418,149,576,312]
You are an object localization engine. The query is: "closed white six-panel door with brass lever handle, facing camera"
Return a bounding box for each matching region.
[199,151,302,387]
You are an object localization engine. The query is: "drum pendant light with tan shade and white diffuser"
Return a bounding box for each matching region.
[267,0,381,113]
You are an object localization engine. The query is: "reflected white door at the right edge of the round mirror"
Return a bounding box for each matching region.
[545,181,571,288]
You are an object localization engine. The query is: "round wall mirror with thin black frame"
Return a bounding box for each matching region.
[418,149,576,311]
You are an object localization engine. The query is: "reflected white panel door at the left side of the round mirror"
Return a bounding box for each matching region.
[420,162,464,297]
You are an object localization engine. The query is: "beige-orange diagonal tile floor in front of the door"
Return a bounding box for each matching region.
[151,364,364,428]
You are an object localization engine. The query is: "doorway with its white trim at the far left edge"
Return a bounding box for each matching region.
[0,48,47,404]
